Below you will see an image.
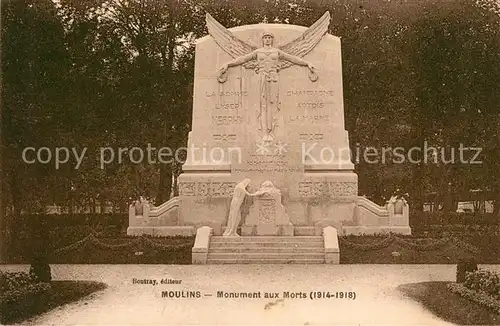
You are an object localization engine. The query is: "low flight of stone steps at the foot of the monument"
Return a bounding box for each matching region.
[207,236,325,264]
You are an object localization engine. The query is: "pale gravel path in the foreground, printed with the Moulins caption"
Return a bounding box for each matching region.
[0,265,500,325]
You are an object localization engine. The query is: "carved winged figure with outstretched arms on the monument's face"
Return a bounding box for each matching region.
[206,11,330,142]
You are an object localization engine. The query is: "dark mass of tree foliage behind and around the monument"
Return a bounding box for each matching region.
[2,0,500,222]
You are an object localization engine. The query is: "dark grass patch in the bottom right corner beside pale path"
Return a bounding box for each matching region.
[398,282,500,325]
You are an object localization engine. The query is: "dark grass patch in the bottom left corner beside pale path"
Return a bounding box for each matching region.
[0,281,107,323]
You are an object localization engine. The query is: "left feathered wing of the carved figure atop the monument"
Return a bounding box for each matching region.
[206,13,257,69]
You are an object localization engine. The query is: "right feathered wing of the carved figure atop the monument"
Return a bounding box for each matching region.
[280,11,330,69]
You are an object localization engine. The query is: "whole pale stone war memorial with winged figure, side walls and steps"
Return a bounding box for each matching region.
[127,12,411,264]
